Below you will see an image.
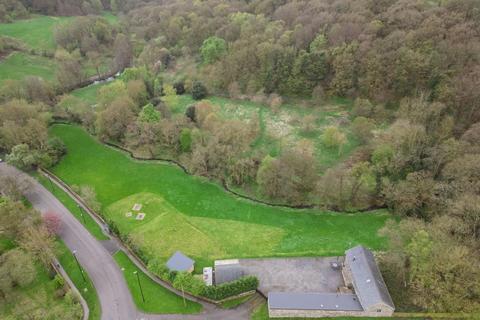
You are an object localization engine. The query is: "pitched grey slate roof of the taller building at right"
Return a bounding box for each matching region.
[345,246,395,310]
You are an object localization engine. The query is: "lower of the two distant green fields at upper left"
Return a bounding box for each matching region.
[0,52,56,83]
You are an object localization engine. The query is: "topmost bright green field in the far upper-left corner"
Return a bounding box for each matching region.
[0,16,71,50]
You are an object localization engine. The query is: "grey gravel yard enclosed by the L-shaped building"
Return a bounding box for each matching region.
[240,257,344,295]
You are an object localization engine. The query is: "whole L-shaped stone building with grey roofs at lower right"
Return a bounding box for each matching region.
[268,246,395,318]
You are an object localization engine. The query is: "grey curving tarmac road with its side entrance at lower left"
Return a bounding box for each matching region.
[0,163,258,320]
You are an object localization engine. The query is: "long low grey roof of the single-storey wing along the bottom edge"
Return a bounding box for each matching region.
[268,292,363,311]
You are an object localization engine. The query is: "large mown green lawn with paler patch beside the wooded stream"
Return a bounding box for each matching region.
[51,125,390,270]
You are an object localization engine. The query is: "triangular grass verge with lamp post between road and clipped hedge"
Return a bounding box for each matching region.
[114,251,202,314]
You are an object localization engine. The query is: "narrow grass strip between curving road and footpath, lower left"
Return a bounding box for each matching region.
[57,240,101,320]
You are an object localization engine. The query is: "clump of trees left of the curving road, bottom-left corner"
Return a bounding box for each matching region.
[0,176,82,319]
